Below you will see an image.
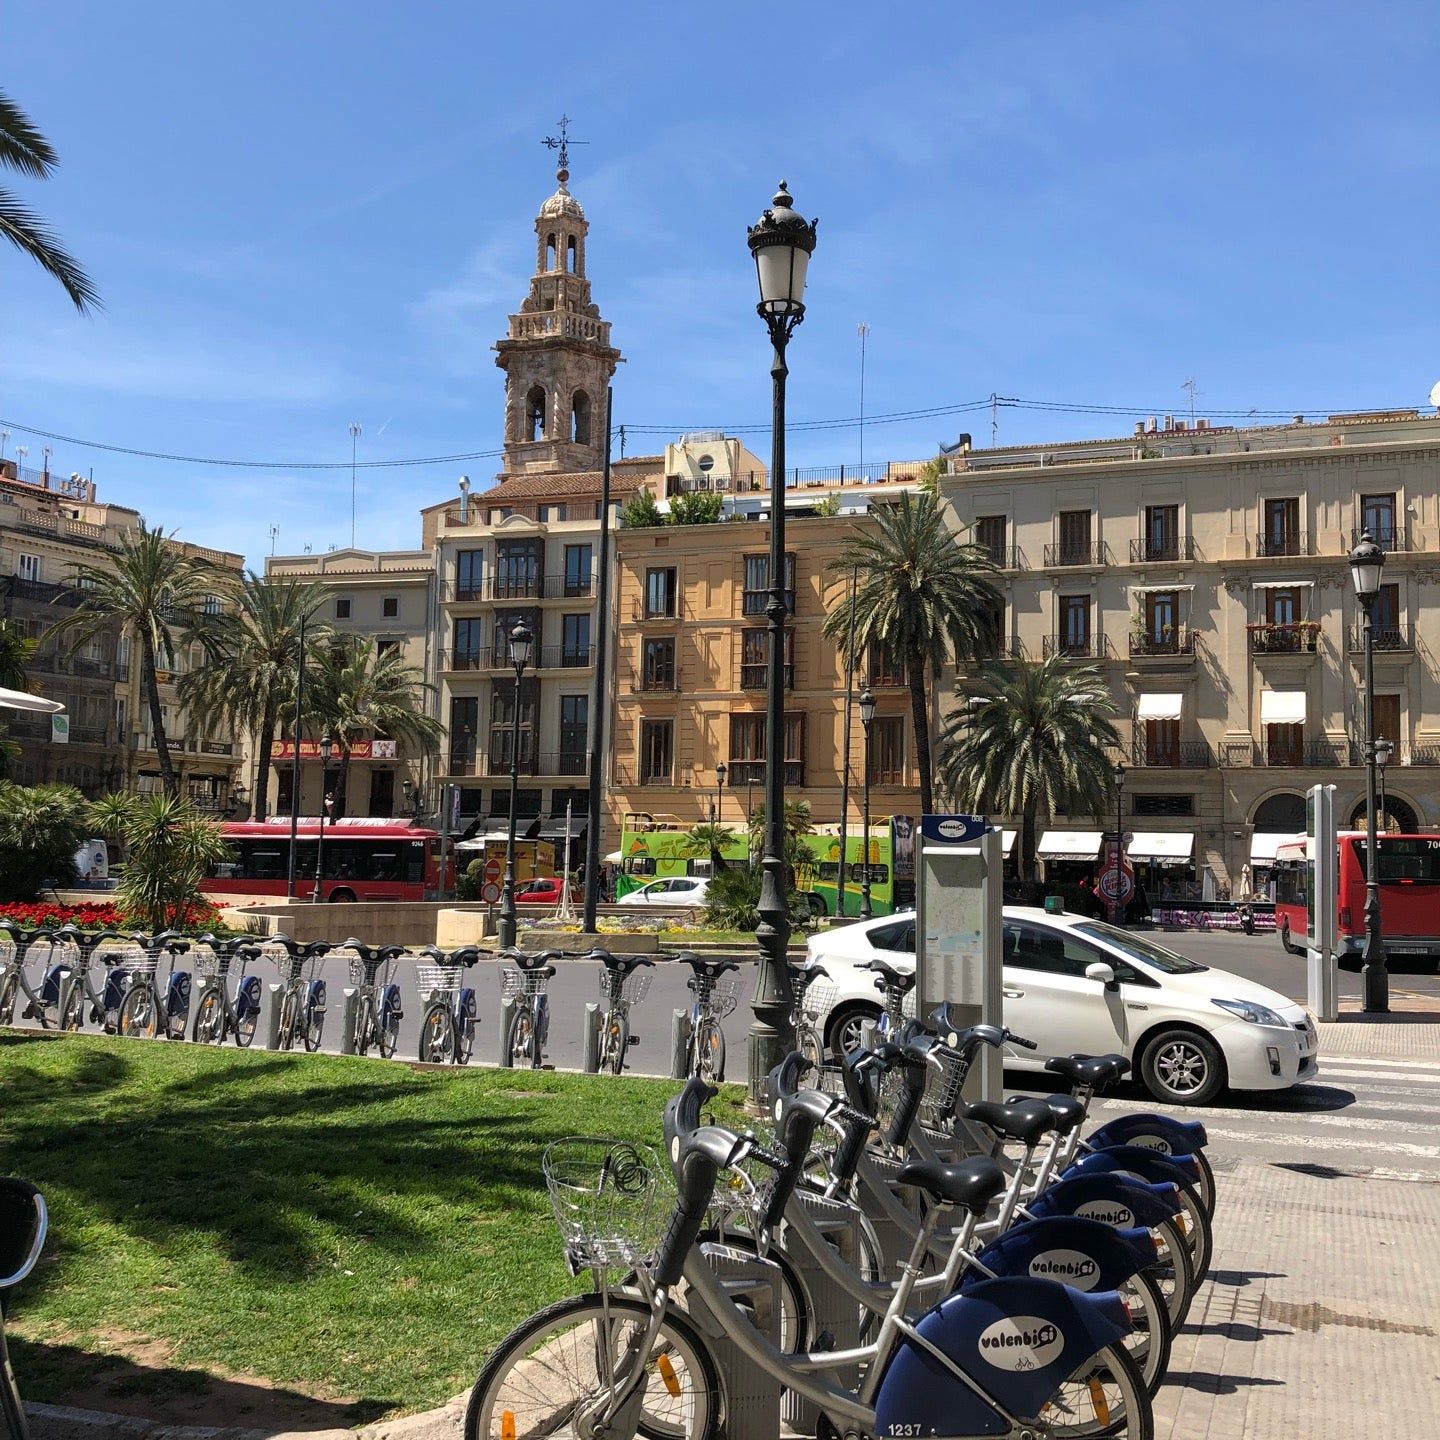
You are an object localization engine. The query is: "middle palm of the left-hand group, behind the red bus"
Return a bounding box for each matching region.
[180,570,328,819]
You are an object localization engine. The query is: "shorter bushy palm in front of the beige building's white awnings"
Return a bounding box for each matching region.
[940,655,1120,880]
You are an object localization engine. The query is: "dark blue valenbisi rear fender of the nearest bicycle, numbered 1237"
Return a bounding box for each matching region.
[876,1276,1130,1440]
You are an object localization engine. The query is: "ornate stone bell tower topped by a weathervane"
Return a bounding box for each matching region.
[495,125,621,475]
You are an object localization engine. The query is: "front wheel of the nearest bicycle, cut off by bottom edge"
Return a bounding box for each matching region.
[465,1295,720,1440]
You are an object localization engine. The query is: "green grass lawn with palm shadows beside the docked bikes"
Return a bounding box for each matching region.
[0,1032,739,1421]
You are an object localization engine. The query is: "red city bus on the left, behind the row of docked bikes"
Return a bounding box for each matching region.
[200,815,439,901]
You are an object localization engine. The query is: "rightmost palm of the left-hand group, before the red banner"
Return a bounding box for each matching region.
[315,635,444,815]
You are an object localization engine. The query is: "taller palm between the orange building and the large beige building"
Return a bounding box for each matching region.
[825,491,1004,815]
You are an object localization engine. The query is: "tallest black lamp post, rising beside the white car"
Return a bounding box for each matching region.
[747,180,815,1102]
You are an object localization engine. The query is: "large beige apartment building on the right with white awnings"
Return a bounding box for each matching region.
[940,410,1440,893]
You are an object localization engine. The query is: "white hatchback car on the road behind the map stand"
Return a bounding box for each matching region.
[808,906,1318,1104]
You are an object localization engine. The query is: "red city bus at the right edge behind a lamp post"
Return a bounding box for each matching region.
[1272,829,1440,972]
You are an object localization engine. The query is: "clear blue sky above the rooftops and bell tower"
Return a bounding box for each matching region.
[0,0,1440,562]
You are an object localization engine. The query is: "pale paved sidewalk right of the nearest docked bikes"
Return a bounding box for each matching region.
[1155,1162,1440,1440]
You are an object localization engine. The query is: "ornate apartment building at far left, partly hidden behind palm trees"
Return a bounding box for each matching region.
[0,461,243,812]
